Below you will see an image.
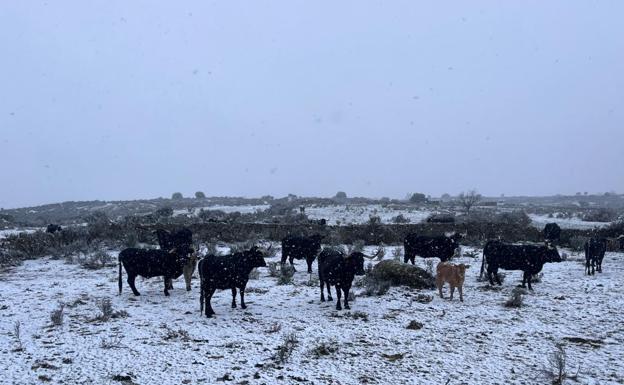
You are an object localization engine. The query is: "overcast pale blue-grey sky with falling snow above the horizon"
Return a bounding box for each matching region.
[0,0,624,208]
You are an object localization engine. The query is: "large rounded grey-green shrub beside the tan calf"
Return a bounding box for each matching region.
[370,260,435,289]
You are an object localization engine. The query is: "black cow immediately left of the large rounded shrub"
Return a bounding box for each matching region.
[318,249,376,310]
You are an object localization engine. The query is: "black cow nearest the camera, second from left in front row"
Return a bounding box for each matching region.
[197,246,270,317]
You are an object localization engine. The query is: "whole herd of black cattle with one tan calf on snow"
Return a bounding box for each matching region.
[113,224,624,317]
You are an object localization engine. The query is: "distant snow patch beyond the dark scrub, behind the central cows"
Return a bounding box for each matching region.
[305,205,431,225]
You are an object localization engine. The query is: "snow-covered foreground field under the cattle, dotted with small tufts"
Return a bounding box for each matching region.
[0,247,624,385]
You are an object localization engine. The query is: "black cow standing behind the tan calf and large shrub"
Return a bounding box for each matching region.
[403,233,462,265]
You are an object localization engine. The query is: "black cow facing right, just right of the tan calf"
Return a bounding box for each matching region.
[481,241,561,290]
